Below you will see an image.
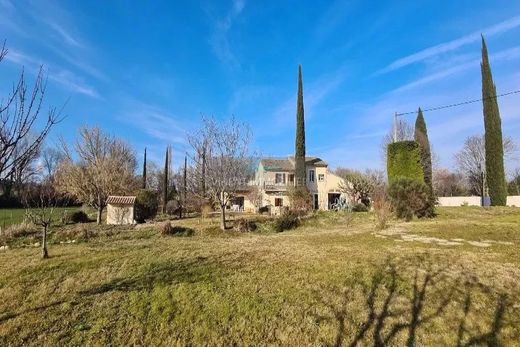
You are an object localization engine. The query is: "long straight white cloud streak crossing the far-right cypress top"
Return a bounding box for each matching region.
[376,16,520,74]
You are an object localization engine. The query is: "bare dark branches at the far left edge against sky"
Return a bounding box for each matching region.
[0,43,62,184]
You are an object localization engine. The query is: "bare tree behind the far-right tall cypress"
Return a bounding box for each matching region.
[455,135,517,195]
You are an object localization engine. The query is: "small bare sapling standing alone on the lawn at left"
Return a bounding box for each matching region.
[26,180,60,259]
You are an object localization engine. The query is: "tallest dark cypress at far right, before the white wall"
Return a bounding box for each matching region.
[480,36,507,206]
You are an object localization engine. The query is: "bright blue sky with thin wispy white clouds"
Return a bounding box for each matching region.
[0,0,520,174]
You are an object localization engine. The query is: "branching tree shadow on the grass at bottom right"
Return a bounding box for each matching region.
[315,258,518,347]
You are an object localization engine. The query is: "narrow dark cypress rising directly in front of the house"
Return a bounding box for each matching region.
[294,65,307,187]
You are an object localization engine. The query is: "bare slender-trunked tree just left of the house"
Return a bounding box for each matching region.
[189,117,253,230]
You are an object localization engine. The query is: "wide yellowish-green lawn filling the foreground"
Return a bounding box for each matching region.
[0,207,520,346]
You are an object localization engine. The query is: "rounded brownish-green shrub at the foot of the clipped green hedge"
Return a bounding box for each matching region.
[388,177,434,221]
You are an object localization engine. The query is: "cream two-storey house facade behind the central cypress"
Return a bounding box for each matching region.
[234,157,346,213]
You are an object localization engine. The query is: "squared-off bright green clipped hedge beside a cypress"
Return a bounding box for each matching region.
[387,141,424,183]
